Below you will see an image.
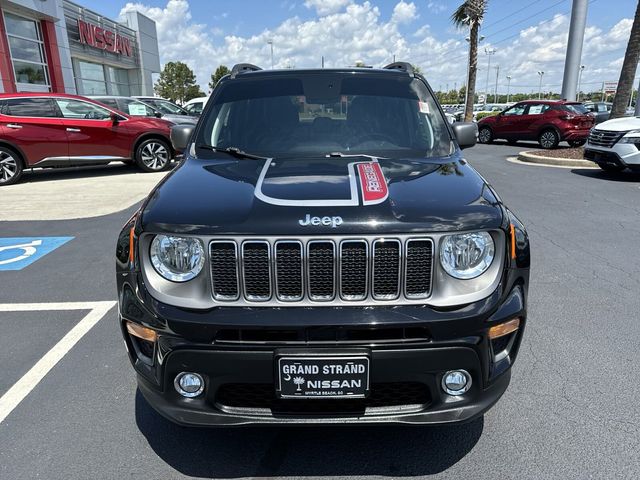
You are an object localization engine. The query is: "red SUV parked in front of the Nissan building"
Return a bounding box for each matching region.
[0,93,174,186]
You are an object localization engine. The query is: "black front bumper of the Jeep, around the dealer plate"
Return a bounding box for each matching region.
[119,269,528,426]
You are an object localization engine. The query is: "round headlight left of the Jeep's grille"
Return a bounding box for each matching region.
[151,235,204,282]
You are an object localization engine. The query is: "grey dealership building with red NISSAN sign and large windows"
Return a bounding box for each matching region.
[0,0,160,95]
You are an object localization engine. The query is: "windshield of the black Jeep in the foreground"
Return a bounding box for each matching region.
[197,73,452,157]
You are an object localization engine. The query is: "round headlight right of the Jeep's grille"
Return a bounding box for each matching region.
[440,232,495,280]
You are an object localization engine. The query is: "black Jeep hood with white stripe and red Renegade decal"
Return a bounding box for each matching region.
[141,156,502,235]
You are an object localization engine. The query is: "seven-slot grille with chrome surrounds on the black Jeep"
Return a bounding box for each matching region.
[209,238,433,303]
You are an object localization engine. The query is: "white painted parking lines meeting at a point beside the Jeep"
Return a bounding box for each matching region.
[0,301,116,423]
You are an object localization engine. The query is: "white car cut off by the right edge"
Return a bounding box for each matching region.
[584,117,640,172]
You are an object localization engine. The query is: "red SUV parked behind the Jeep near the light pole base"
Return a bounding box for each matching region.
[478,100,595,148]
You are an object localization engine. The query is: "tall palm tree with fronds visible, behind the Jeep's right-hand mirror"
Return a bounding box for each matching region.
[451,0,489,122]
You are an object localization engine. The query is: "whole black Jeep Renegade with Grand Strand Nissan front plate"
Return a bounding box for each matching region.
[116,63,529,425]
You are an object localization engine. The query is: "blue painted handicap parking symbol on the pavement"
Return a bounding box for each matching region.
[0,237,74,271]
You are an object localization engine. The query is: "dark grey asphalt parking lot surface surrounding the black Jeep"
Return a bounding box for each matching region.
[0,144,640,479]
